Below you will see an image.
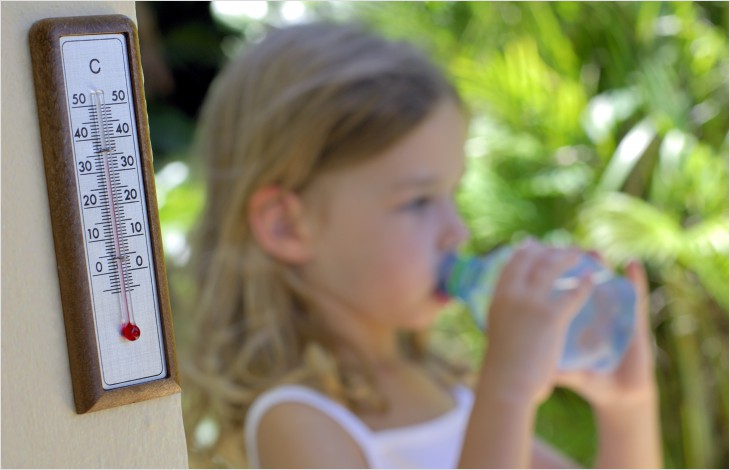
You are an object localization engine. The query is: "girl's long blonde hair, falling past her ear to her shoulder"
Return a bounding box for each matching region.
[182,23,460,465]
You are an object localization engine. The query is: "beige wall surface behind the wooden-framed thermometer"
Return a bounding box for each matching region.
[0,1,188,468]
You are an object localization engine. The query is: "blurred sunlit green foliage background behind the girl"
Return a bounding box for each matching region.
[137,1,729,468]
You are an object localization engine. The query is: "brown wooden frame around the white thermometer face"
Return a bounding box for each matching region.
[29,15,181,413]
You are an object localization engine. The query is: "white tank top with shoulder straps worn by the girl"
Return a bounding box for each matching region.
[244,385,474,468]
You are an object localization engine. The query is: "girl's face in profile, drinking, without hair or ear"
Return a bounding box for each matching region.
[301,101,468,330]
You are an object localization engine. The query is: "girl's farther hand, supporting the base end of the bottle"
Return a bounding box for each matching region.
[557,261,656,408]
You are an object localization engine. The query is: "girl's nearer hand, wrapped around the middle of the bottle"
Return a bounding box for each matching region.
[481,241,591,404]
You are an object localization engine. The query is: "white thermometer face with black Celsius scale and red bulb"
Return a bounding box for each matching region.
[60,34,167,390]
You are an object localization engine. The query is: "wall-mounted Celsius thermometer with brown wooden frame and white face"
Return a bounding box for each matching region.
[30,15,180,413]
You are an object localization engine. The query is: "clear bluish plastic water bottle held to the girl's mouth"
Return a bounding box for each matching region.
[439,246,636,372]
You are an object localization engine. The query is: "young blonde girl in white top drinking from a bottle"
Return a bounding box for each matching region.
[185,24,661,468]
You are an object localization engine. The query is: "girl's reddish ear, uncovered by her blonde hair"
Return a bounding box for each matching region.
[248,186,311,264]
